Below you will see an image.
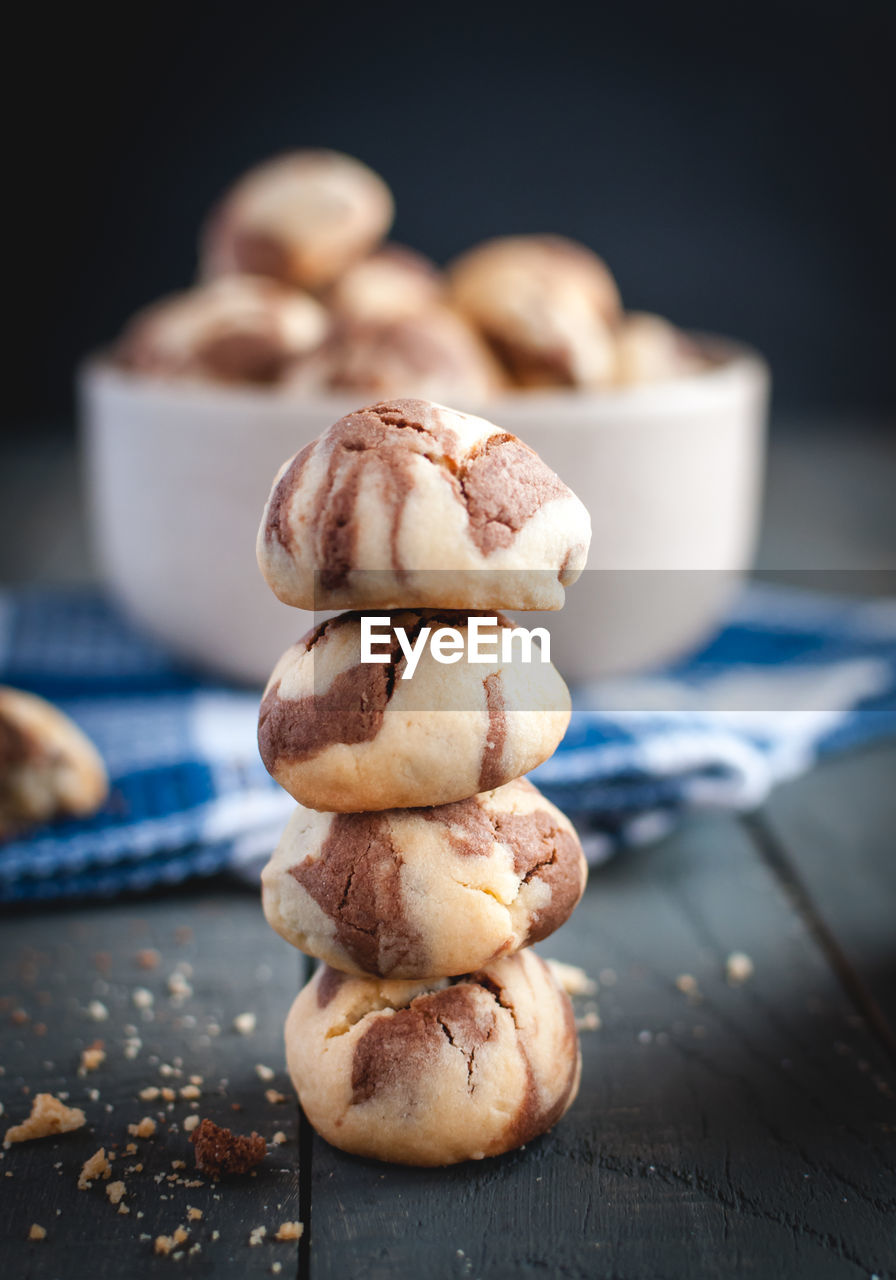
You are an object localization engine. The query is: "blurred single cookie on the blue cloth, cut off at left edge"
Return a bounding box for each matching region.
[0,686,109,840]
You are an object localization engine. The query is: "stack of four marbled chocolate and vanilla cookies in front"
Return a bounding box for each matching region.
[259,399,590,1165]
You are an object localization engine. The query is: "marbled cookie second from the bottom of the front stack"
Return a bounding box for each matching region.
[261,778,588,978]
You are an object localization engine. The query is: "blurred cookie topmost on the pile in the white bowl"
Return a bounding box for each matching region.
[201,150,394,291]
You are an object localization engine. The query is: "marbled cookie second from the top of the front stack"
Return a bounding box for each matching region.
[259,611,570,813]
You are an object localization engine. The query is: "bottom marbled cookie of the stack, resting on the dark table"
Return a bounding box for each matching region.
[285,951,581,1165]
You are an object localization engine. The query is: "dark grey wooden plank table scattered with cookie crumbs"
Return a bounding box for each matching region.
[0,428,896,1280]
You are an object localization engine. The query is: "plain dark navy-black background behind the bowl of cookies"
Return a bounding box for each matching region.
[5,0,896,429]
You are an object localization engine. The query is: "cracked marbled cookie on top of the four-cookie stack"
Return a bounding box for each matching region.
[257,399,591,609]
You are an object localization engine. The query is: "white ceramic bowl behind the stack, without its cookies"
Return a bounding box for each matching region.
[81,339,768,684]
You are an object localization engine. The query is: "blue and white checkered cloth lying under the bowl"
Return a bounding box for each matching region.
[0,586,896,902]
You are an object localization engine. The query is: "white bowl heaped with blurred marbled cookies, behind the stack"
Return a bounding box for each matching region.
[81,151,768,684]
